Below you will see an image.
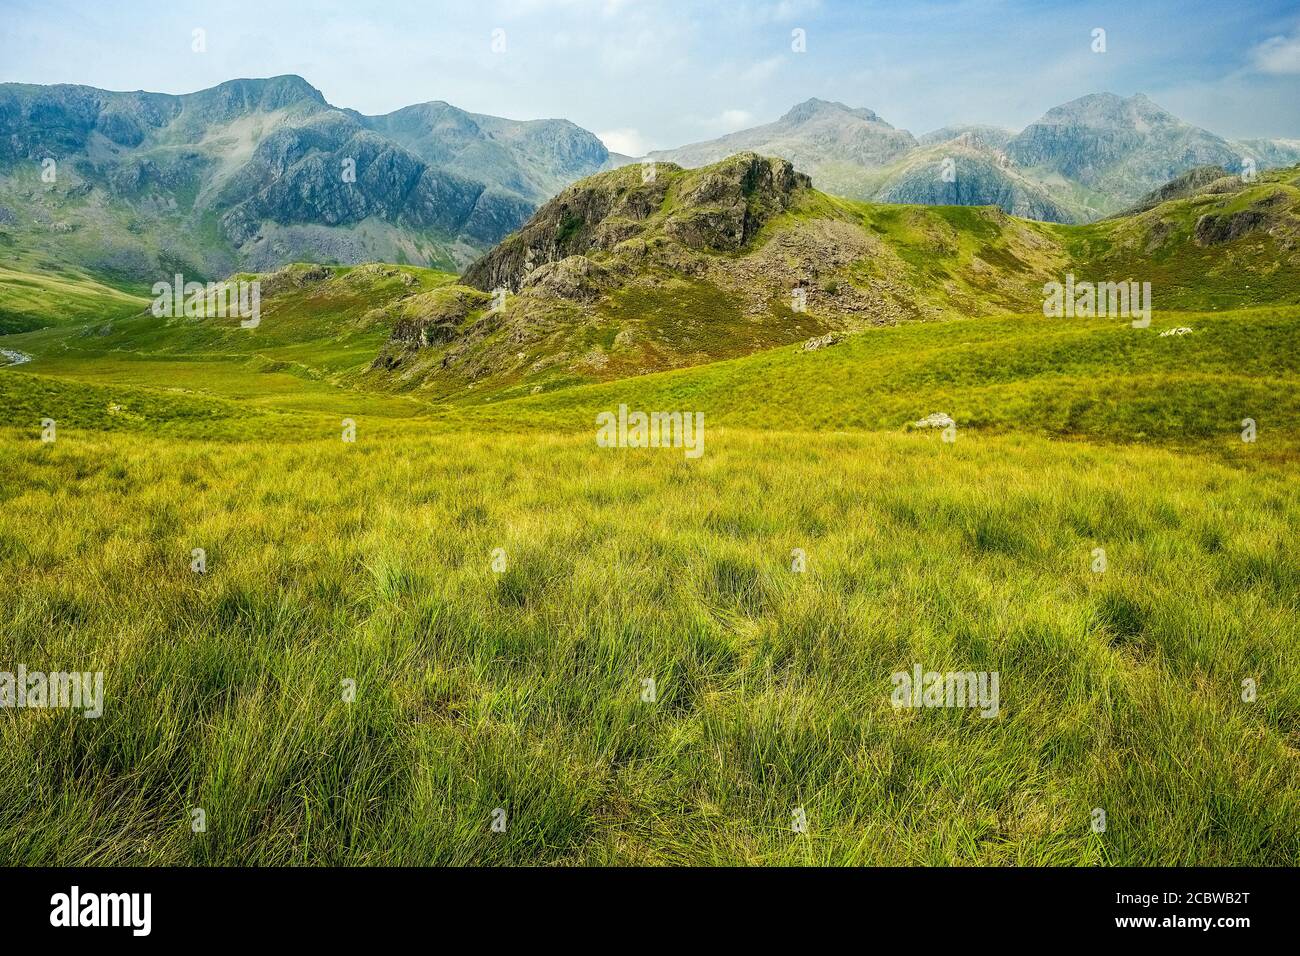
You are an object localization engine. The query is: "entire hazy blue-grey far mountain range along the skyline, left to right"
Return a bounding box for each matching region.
[0,75,1300,284]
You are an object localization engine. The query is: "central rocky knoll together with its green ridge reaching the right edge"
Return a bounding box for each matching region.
[358,153,1300,401]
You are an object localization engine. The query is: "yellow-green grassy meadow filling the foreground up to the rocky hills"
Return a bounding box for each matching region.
[0,261,1300,865]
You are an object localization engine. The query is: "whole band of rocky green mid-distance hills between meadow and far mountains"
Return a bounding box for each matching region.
[15,146,1300,405]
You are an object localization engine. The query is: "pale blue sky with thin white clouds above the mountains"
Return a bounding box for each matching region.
[0,0,1300,153]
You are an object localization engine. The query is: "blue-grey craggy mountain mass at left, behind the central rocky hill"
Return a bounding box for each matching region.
[0,77,608,282]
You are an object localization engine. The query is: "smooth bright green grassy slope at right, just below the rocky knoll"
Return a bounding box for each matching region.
[458,307,1300,453]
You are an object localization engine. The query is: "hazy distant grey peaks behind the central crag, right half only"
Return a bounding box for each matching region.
[646,94,1300,222]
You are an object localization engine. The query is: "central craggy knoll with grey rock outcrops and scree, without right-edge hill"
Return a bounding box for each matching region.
[376,153,1063,395]
